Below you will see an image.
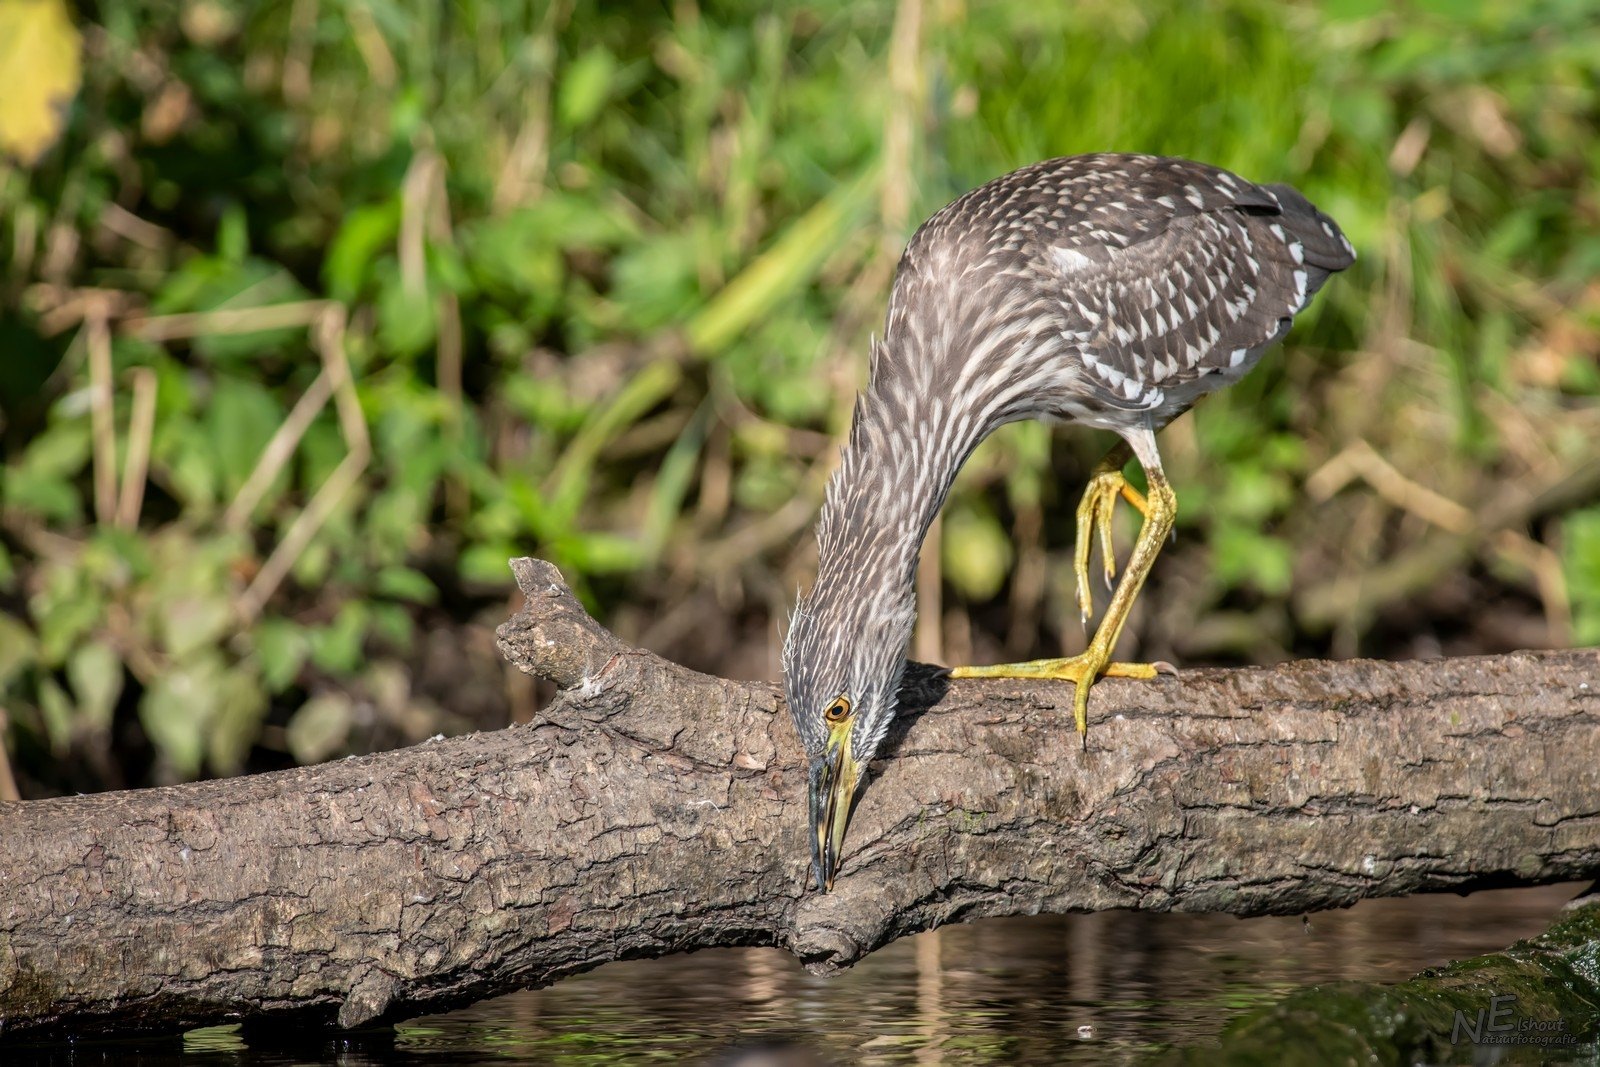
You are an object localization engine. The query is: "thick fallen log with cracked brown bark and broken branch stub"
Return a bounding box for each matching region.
[0,560,1600,1040]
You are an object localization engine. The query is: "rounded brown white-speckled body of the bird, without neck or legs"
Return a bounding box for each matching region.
[882,155,1355,429]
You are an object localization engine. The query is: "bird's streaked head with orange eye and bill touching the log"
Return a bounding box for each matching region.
[784,579,915,893]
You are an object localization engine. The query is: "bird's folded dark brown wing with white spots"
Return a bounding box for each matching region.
[1032,157,1355,410]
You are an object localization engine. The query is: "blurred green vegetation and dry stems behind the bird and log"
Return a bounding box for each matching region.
[0,0,1600,795]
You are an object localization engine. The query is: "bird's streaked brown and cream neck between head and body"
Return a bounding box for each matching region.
[818,364,982,595]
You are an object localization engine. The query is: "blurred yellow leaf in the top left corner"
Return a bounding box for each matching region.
[0,0,82,165]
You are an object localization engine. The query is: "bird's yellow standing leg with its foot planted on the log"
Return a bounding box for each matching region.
[950,432,1178,741]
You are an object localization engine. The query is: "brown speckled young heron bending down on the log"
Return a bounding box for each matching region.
[782,152,1355,893]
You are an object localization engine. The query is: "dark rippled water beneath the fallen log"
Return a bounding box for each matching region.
[19,886,1579,1067]
